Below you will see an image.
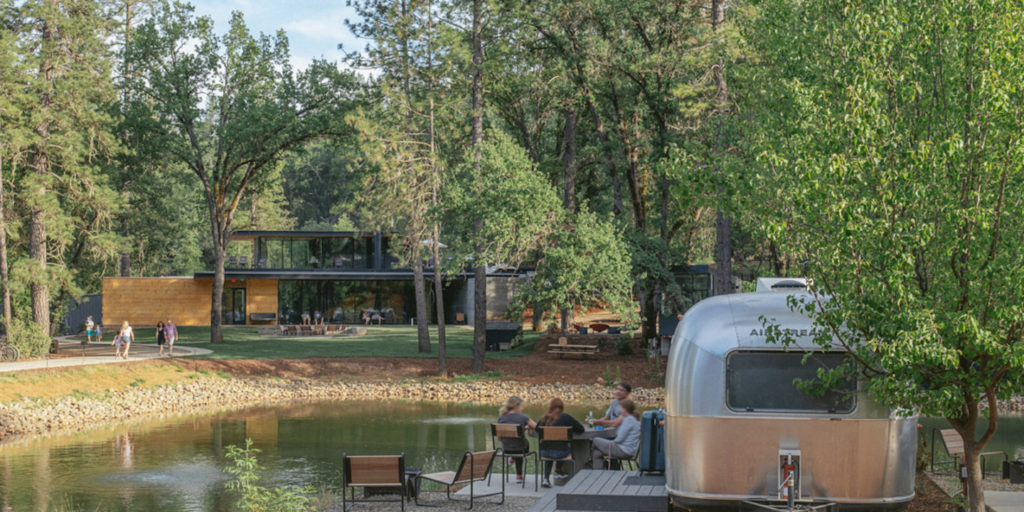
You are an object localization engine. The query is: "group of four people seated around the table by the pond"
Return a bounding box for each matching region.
[498,382,640,487]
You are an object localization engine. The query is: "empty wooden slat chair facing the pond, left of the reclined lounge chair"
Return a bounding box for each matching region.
[341,454,409,512]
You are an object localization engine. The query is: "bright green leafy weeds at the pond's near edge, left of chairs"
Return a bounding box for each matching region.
[224,438,316,512]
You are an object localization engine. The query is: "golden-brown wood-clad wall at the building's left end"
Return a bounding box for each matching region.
[103,278,211,327]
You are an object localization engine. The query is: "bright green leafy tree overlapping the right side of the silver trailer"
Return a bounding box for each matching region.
[746,0,1024,512]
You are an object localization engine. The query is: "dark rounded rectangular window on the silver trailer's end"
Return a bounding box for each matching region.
[726,351,857,413]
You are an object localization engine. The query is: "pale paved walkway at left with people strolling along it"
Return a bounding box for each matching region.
[0,338,212,373]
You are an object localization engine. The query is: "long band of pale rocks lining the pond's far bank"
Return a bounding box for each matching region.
[0,377,665,440]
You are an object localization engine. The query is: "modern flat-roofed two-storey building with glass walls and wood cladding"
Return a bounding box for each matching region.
[102,231,524,326]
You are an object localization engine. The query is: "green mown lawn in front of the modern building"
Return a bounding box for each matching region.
[135,326,540,359]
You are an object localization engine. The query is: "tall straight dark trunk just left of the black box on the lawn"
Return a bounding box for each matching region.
[470,0,487,372]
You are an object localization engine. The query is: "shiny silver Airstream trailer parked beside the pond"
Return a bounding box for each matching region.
[665,287,918,510]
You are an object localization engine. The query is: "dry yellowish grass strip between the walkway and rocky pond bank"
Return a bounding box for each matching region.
[0,364,205,401]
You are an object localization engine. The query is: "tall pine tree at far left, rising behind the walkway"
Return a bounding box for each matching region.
[19,0,116,334]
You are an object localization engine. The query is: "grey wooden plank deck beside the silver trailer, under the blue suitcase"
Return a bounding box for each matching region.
[529,469,669,512]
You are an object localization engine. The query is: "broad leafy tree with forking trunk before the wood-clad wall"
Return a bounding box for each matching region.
[127,3,357,343]
